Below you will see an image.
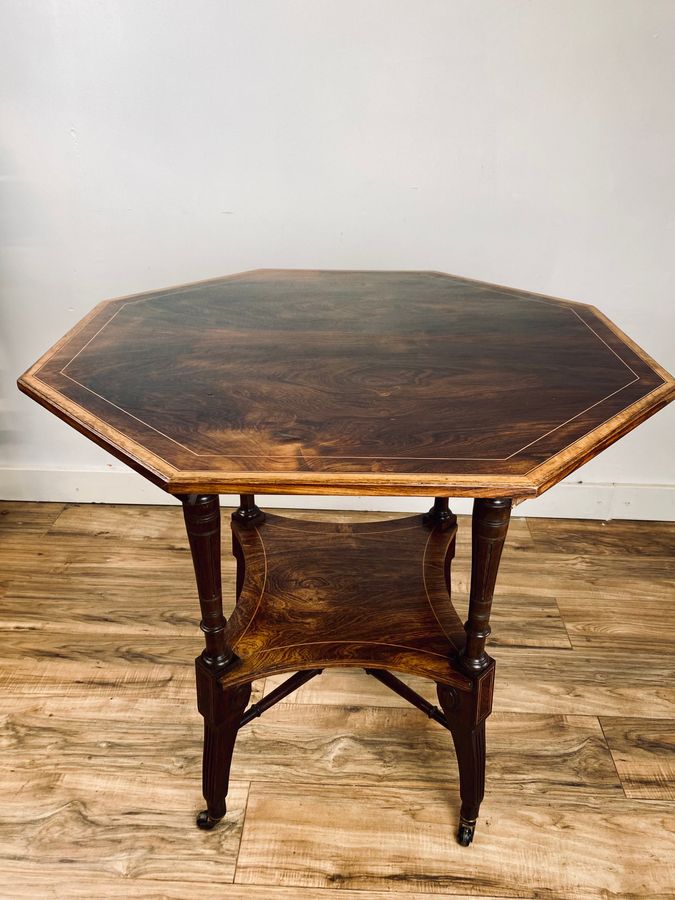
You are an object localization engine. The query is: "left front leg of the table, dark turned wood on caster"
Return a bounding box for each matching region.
[181,494,251,829]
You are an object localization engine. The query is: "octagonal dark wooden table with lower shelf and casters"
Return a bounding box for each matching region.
[19,270,675,845]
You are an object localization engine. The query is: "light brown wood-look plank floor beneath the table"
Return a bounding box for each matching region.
[0,503,675,900]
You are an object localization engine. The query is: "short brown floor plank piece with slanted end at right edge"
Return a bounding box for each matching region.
[600,717,675,800]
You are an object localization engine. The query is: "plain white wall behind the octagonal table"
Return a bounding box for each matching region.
[0,0,675,518]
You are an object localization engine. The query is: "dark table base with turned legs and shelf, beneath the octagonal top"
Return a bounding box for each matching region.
[183,495,511,846]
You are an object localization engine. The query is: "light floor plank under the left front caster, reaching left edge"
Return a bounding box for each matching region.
[0,766,248,884]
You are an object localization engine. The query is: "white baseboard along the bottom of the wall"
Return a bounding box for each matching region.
[0,467,675,521]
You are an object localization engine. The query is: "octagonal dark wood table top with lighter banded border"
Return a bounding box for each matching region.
[19,270,675,499]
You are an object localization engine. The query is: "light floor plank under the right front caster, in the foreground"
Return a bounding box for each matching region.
[235,781,675,900]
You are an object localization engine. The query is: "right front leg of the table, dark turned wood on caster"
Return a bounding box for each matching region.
[438,499,511,847]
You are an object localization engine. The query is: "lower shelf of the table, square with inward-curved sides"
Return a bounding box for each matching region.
[221,514,472,690]
